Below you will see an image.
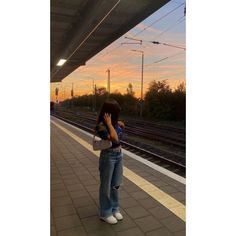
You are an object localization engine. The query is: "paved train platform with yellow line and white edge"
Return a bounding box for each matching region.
[51,117,185,236]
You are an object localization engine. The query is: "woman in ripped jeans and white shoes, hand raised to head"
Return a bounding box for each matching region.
[96,99,124,224]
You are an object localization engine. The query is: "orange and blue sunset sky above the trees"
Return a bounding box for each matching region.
[51,0,186,101]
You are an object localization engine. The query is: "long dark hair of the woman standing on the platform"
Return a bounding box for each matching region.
[98,98,121,127]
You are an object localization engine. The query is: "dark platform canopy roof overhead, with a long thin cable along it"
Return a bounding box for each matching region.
[50,0,170,82]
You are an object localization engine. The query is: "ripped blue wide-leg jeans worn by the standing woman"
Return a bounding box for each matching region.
[99,149,123,217]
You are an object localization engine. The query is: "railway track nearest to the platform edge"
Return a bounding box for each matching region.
[51,114,186,177]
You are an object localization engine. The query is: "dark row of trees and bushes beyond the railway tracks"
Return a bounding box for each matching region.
[61,80,186,121]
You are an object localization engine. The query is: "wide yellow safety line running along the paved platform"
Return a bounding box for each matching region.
[51,120,186,221]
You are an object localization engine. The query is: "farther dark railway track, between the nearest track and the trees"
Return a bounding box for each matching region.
[52,110,185,149]
